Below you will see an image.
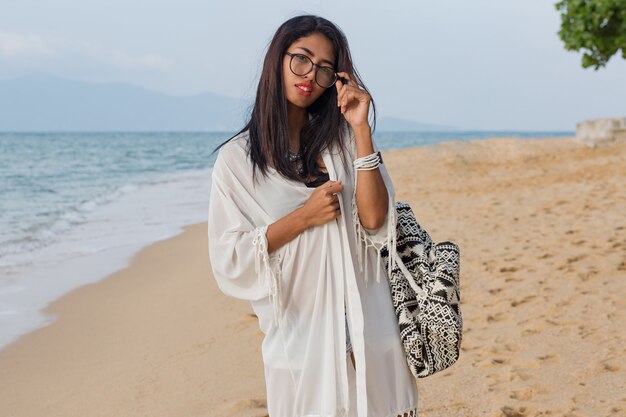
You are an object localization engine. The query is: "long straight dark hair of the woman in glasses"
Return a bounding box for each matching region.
[213,15,376,181]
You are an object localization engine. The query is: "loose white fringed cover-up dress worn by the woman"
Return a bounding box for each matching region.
[208,130,418,417]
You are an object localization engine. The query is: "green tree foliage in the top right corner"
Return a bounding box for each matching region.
[555,0,626,70]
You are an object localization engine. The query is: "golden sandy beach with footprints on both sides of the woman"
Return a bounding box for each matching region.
[0,138,626,417]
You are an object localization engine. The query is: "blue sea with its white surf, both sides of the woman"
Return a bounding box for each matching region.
[0,131,574,348]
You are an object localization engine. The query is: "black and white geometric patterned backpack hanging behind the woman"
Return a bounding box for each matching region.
[381,201,463,378]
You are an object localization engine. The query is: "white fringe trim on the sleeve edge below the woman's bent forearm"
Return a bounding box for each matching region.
[252,225,282,327]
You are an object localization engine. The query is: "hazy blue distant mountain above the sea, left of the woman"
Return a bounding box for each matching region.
[0,75,246,131]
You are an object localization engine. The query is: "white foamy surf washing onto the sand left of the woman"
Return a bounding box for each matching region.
[0,169,211,349]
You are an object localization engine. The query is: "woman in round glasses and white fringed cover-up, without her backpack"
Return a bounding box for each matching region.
[209,16,417,417]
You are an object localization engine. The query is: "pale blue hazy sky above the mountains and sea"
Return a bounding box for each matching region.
[0,0,626,131]
